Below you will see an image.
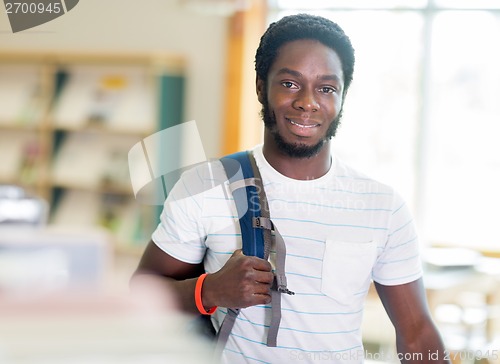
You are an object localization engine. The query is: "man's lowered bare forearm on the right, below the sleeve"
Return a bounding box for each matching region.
[375,279,450,363]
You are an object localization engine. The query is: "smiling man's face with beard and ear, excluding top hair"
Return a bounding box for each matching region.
[257,40,344,158]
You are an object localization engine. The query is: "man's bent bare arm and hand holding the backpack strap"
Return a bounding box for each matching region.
[131,241,274,313]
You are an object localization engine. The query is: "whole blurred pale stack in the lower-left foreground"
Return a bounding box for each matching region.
[0,187,211,364]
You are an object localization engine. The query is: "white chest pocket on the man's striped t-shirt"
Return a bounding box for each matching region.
[321,239,377,305]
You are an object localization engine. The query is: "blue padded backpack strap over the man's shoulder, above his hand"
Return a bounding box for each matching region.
[220,151,264,258]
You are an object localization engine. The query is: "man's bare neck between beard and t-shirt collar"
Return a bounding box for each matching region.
[262,133,332,180]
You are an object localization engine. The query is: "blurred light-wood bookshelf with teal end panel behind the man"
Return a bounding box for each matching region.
[0,52,185,253]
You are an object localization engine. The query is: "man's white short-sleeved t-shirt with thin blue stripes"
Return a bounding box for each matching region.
[153,146,422,363]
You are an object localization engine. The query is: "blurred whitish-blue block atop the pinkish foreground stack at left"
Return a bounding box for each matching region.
[0,227,112,294]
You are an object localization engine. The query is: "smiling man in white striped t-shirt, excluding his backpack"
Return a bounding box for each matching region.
[132,14,446,363]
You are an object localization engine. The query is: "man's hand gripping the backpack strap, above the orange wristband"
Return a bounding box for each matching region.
[202,249,274,308]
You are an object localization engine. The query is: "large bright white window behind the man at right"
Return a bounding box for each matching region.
[269,0,500,252]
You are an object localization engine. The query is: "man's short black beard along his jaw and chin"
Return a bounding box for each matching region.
[260,100,342,158]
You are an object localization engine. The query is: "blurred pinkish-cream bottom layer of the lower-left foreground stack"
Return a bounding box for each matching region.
[0,291,211,364]
